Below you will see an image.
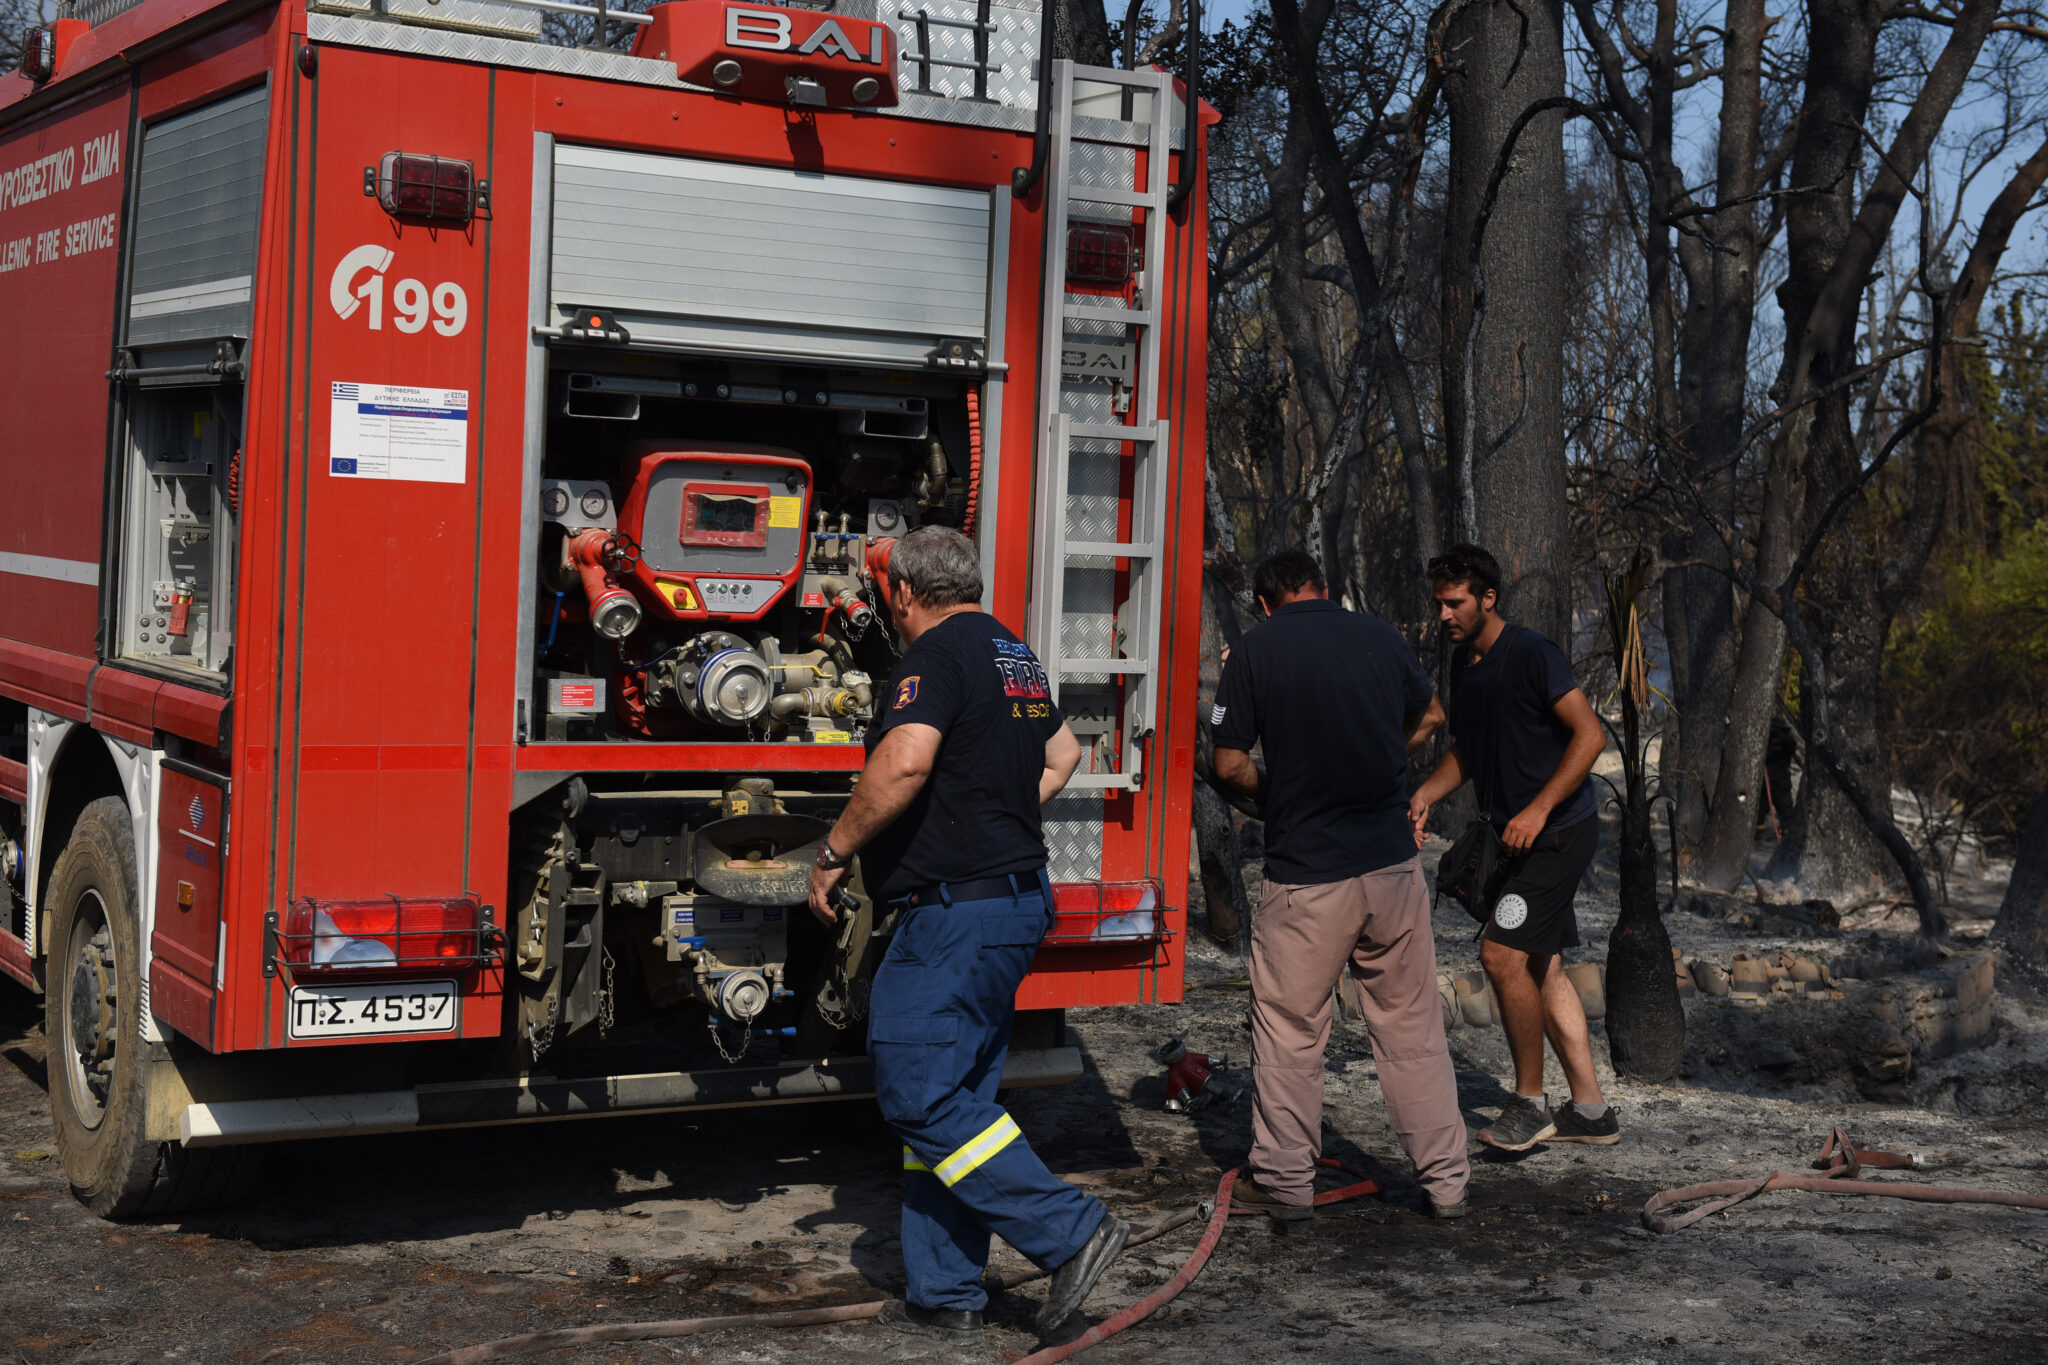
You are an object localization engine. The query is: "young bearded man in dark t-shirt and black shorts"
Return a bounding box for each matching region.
[1409,544,1622,1152]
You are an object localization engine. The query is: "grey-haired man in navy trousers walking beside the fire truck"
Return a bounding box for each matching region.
[811,526,1130,1345]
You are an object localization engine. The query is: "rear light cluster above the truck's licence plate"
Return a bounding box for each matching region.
[276,896,496,976]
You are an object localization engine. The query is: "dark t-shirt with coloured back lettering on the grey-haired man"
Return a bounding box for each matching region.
[860,612,1063,900]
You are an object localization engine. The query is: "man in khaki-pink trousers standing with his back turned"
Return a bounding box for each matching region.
[1210,551,1470,1222]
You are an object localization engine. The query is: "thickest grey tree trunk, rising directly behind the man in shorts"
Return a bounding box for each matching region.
[1440,0,1571,647]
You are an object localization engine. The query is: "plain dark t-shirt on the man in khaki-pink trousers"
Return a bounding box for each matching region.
[1210,600,1432,886]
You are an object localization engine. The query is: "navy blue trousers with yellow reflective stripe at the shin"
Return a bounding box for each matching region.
[868,879,1104,1310]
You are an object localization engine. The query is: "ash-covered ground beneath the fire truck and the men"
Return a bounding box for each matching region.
[0,826,2048,1365]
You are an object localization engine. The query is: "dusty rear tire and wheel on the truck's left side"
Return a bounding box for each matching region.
[43,796,264,1218]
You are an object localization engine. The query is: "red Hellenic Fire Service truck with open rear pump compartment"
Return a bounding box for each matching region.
[0,0,1212,1216]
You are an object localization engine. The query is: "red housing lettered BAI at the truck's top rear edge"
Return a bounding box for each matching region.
[633,0,897,108]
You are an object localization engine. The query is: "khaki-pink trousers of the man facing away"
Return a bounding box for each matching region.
[1251,857,1473,1203]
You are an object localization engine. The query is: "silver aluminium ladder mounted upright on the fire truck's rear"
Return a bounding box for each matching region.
[1026,59,1178,792]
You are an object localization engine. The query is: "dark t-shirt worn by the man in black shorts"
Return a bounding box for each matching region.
[1450,624,1599,831]
